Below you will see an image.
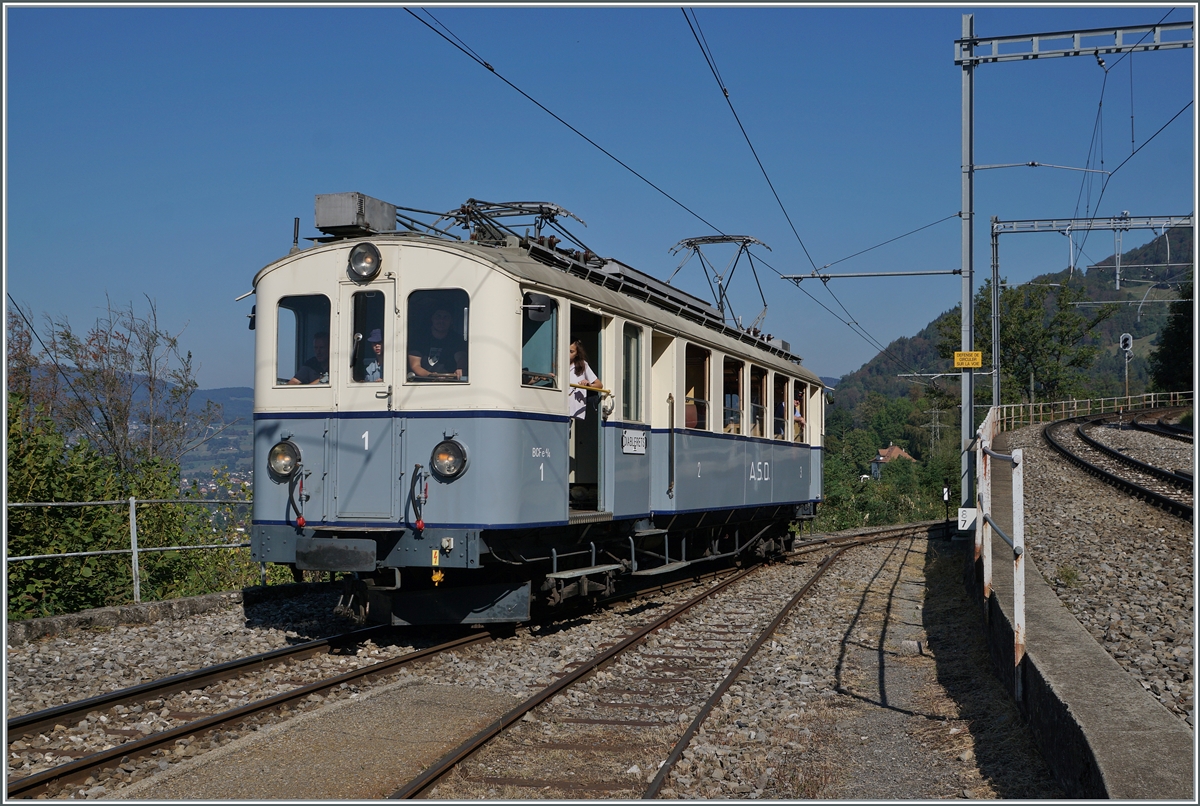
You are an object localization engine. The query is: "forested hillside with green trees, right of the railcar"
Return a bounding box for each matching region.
[818,228,1194,528]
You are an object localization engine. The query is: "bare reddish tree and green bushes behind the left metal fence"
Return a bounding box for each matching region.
[6,298,258,619]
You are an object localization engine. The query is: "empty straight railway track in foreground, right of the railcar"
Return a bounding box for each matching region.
[391,527,929,799]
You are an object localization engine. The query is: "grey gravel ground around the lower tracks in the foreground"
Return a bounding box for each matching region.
[8,527,1061,800]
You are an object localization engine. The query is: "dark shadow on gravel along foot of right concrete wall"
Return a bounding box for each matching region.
[923,540,1067,800]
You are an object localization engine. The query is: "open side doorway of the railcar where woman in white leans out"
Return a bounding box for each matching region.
[568,306,604,510]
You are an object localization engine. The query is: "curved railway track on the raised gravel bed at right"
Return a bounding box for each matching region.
[1042,415,1195,522]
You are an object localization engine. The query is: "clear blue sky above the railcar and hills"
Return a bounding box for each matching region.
[5,5,1196,387]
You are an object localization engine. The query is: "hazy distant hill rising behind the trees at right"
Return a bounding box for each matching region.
[834,228,1193,409]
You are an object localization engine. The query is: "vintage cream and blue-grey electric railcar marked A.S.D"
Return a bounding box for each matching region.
[251,193,824,625]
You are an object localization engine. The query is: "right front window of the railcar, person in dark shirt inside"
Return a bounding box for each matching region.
[406,288,470,383]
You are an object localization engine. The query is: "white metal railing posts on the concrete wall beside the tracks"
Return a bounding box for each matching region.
[974,407,1025,702]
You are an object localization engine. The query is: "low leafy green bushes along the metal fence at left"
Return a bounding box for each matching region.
[7,395,274,619]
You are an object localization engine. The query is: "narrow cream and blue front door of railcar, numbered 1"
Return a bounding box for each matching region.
[330,279,403,525]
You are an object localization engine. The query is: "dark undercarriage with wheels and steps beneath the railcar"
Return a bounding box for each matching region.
[319,504,812,625]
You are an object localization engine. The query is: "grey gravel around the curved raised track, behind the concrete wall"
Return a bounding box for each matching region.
[1008,426,1195,728]
